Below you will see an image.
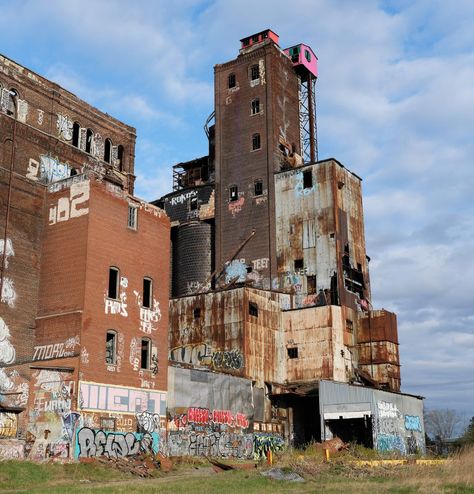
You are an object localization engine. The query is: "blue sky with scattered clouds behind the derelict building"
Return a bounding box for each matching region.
[0,0,474,417]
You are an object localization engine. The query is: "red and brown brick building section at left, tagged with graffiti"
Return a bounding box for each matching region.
[0,57,169,459]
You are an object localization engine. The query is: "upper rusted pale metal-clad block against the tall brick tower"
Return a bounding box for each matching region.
[274,160,370,309]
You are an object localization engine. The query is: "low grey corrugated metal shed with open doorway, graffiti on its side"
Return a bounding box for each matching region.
[319,381,425,455]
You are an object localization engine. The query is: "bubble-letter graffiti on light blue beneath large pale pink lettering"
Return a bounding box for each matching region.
[75,427,159,458]
